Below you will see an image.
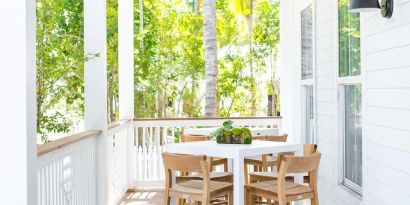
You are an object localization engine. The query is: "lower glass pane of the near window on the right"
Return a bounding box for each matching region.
[345,85,362,186]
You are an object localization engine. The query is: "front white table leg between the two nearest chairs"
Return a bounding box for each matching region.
[233,156,245,205]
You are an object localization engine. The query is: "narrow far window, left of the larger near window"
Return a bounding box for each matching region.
[301,4,314,143]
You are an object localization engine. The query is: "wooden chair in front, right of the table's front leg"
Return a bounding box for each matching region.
[245,152,321,205]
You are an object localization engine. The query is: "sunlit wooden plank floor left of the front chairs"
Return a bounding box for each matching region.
[120,191,310,205]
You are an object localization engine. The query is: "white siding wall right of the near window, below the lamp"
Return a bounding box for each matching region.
[362,0,410,205]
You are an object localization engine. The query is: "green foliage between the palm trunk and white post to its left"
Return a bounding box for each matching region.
[135,0,204,118]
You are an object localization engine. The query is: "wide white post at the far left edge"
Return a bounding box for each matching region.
[0,0,37,205]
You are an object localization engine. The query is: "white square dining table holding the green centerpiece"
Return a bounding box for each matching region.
[167,140,303,205]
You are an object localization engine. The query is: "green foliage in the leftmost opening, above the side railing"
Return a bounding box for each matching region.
[36,0,85,142]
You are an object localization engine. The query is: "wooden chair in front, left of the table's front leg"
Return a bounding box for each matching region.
[162,152,233,205]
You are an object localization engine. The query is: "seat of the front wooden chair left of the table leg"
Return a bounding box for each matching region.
[170,180,233,196]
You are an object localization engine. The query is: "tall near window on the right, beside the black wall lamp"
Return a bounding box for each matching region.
[338,0,362,194]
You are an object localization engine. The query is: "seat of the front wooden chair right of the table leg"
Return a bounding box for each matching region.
[245,180,313,198]
